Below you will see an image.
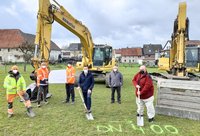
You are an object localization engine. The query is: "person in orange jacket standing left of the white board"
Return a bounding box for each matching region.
[37,62,49,107]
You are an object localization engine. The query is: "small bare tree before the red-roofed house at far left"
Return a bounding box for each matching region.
[19,41,35,71]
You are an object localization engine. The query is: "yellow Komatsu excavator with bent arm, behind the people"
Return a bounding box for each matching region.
[32,0,115,83]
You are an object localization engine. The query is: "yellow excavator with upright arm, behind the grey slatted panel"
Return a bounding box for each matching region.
[158,3,200,79]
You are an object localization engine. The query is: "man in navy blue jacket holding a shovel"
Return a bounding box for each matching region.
[78,66,94,113]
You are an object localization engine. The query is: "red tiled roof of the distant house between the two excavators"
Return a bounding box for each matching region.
[121,48,142,56]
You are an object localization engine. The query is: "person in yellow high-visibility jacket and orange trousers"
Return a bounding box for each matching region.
[3,65,35,118]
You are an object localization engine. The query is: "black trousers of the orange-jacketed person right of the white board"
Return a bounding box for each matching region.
[65,84,75,102]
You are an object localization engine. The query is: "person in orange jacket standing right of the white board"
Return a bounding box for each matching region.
[64,62,75,104]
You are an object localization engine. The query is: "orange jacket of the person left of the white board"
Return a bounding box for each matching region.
[37,68,49,85]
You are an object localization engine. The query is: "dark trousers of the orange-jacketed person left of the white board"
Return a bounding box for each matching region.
[37,85,48,104]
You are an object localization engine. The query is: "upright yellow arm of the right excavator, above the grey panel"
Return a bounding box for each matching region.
[169,2,189,77]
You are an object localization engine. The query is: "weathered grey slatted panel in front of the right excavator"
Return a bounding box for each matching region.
[156,79,200,120]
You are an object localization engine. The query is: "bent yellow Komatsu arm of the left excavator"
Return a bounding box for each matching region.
[32,0,94,69]
